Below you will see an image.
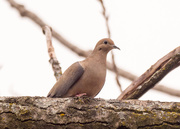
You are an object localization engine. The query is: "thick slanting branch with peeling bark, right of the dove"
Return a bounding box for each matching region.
[118,47,180,100]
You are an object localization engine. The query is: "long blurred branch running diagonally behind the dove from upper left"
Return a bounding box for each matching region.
[7,0,180,97]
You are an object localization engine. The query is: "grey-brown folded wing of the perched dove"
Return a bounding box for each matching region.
[47,62,84,98]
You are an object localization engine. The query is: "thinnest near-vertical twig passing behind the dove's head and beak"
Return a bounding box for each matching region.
[99,0,122,92]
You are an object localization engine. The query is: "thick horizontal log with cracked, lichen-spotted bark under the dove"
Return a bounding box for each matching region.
[0,97,180,129]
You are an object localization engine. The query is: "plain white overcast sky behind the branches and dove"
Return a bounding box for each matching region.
[0,0,180,101]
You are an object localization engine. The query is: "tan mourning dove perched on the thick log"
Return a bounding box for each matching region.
[47,38,120,98]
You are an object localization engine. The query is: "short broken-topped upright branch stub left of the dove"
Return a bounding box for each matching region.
[43,25,62,80]
